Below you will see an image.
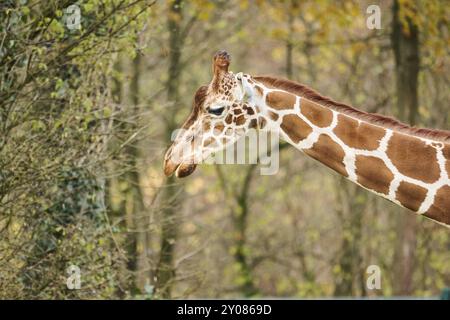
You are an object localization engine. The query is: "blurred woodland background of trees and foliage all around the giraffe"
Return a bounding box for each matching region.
[0,0,450,299]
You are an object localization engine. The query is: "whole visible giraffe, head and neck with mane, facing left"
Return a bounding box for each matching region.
[164,51,450,228]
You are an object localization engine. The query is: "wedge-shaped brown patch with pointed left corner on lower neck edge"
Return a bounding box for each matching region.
[306,134,348,177]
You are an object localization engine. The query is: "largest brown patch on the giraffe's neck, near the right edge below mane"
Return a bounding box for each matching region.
[386,133,440,183]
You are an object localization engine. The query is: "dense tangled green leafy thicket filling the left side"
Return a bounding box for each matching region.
[0,0,151,298]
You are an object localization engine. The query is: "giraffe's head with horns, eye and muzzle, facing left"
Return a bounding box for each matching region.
[164,51,257,178]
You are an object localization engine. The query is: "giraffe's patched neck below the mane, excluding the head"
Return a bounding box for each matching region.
[247,77,450,226]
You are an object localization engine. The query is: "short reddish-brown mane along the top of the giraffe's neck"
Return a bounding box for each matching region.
[253,76,450,143]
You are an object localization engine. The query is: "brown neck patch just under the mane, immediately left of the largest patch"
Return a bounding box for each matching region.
[333,114,386,150]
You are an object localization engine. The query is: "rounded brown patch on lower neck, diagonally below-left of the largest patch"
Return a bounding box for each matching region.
[355,155,394,194]
